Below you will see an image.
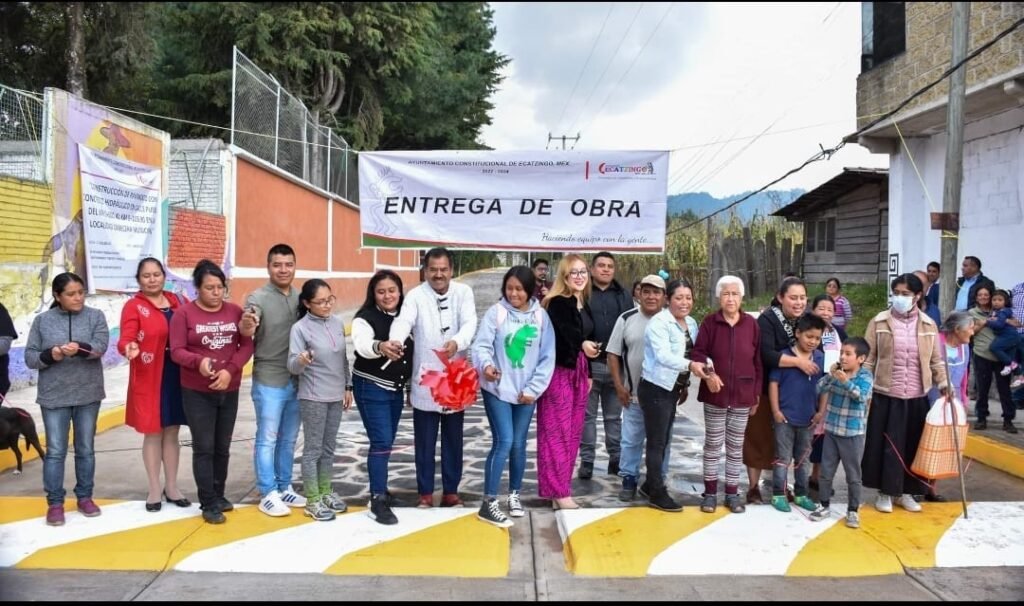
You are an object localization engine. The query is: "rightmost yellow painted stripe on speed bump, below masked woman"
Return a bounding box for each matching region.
[860,503,964,568]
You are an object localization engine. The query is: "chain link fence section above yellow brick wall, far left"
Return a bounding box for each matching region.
[0,84,46,182]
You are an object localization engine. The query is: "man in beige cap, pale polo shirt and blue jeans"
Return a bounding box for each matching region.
[606,274,671,501]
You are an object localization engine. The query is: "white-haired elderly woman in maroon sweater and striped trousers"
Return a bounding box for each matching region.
[690,275,762,514]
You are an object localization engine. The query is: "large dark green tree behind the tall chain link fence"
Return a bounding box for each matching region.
[155,2,507,148]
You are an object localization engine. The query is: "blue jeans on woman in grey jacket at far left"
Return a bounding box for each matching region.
[42,402,99,505]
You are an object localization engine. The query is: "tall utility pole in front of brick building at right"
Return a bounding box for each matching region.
[932,2,971,313]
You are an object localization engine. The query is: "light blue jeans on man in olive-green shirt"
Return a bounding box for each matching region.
[253,381,302,495]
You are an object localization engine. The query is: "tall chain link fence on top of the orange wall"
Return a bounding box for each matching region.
[231,48,359,204]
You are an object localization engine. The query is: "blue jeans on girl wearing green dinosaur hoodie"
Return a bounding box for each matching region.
[483,390,537,497]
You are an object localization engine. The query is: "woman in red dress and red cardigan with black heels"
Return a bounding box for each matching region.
[118,257,191,512]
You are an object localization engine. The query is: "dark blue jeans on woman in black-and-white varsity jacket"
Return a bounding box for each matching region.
[352,377,403,494]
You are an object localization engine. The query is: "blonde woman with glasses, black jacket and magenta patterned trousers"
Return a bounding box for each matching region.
[537,255,601,509]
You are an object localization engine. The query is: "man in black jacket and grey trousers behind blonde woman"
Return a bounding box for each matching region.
[580,251,633,480]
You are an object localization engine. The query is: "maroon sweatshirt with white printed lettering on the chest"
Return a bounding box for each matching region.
[169,301,253,393]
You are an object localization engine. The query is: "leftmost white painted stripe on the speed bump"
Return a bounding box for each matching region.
[0,501,207,568]
